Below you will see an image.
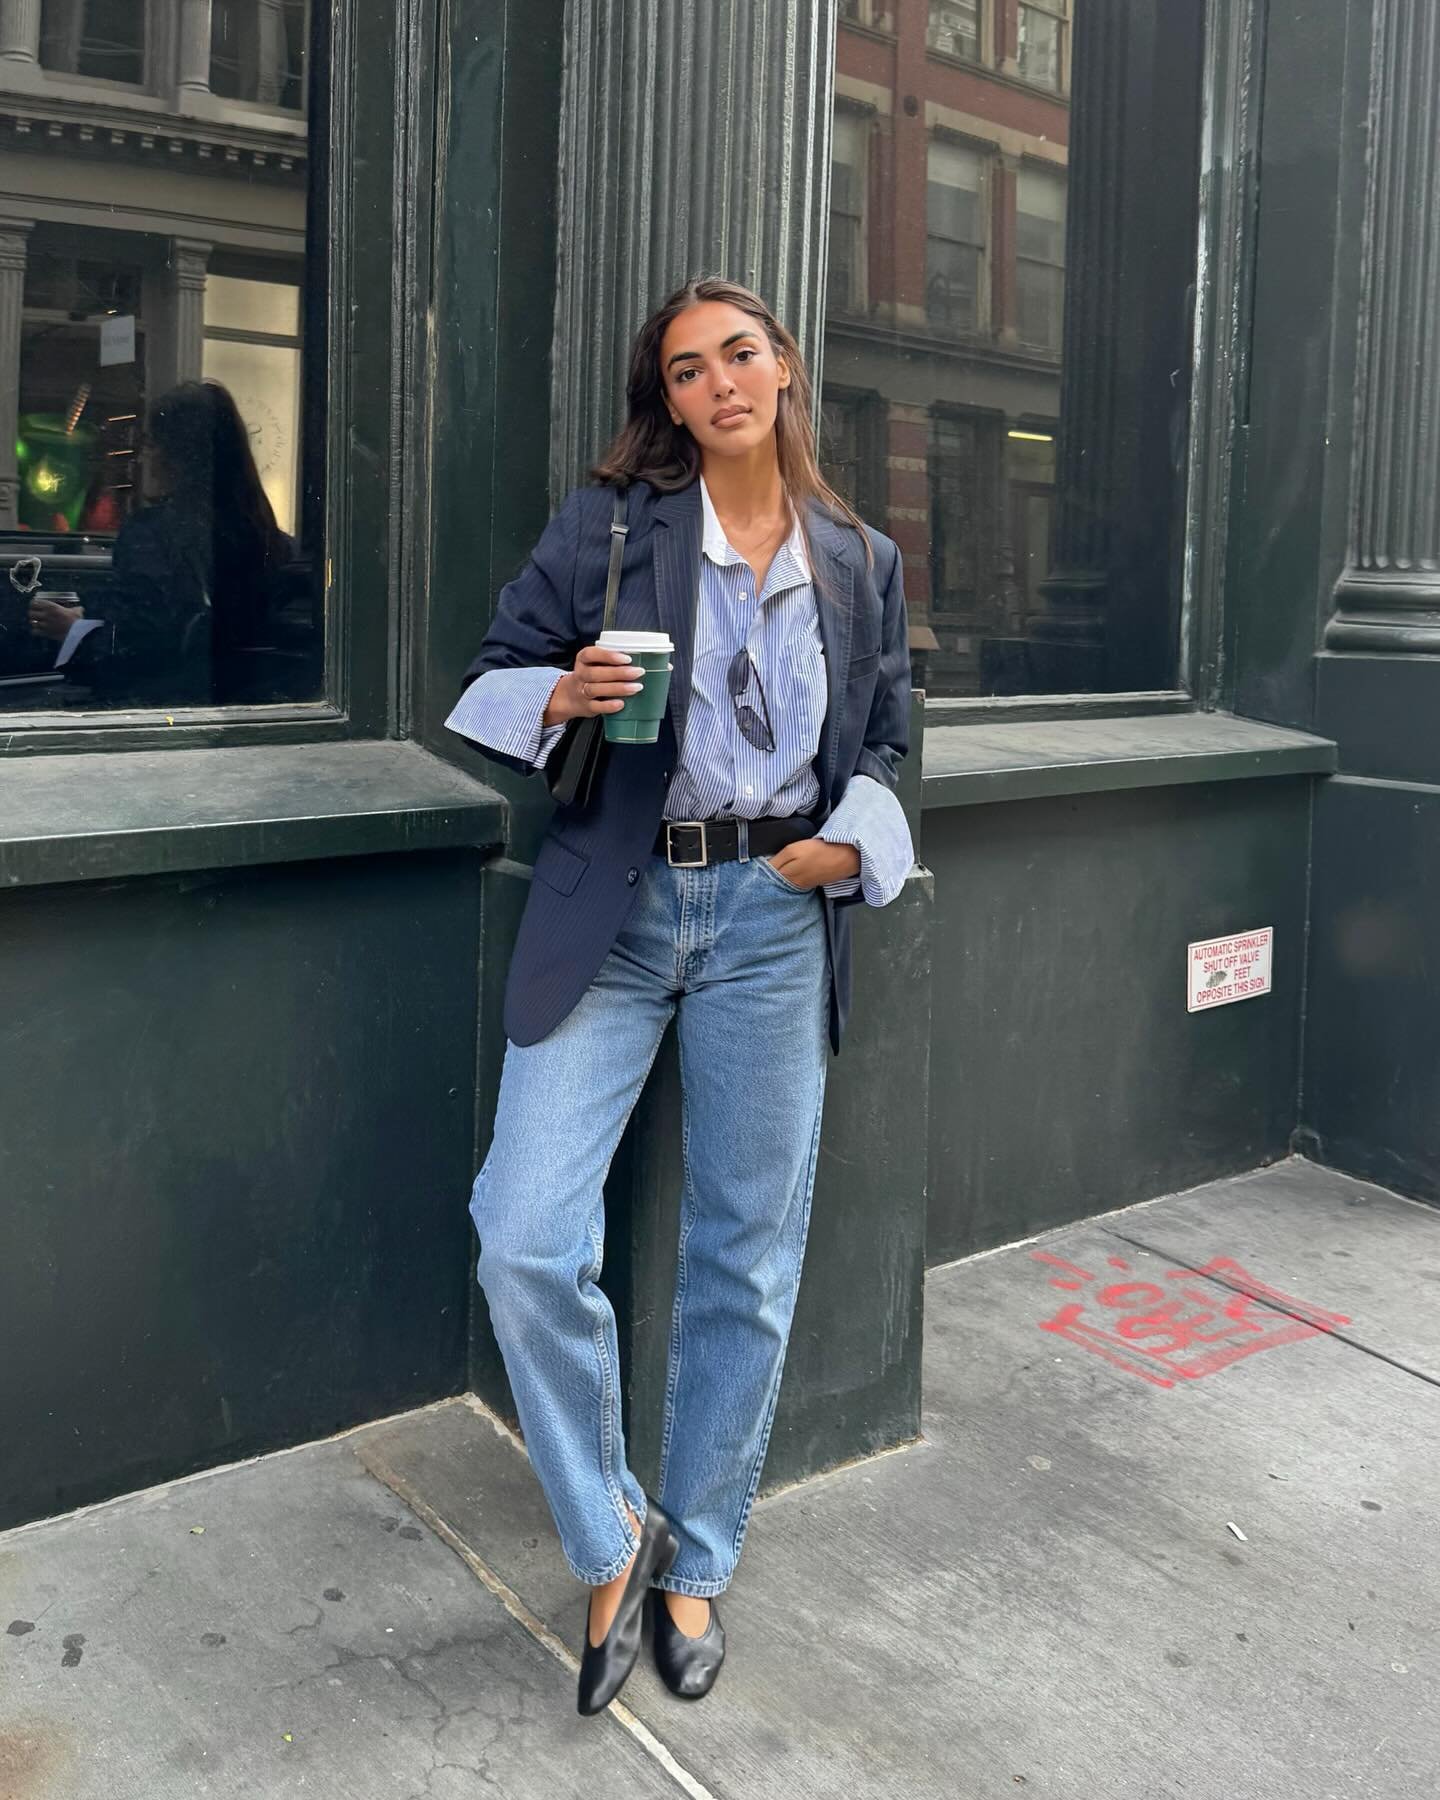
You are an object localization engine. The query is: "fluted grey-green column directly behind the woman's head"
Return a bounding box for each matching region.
[551,0,835,497]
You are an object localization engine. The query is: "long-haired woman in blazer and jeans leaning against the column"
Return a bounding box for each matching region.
[448,279,913,1714]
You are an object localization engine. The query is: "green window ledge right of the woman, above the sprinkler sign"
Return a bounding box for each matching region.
[922,713,1337,810]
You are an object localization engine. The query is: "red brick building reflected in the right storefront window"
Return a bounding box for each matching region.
[824,0,1071,695]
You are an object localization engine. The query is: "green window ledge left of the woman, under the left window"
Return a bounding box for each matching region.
[0,742,508,889]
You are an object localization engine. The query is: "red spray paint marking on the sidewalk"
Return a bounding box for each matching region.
[1031,1249,1350,1388]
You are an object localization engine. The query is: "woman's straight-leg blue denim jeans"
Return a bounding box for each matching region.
[470,857,830,1595]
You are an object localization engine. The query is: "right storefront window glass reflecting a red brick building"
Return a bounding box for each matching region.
[823,0,1204,698]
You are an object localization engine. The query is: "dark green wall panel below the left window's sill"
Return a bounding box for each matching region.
[0,853,481,1528]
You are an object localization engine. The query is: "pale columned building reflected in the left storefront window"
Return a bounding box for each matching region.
[0,0,317,704]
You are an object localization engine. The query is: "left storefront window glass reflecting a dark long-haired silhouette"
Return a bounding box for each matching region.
[0,0,324,715]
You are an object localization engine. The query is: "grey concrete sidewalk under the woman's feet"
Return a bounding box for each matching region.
[0,1161,1440,1800]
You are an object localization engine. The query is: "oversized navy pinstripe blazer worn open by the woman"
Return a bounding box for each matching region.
[464,482,911,1051]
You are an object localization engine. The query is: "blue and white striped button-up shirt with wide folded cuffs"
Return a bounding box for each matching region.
[446,477,914,905]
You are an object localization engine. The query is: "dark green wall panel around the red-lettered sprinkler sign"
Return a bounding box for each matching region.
[923,778,1310,1264]
